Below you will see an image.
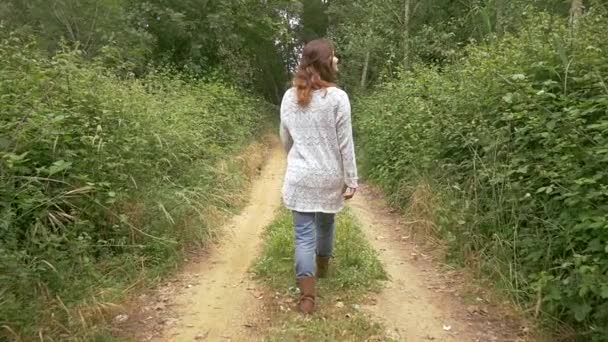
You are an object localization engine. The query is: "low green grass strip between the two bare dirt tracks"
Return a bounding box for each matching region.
[254,210,390,341]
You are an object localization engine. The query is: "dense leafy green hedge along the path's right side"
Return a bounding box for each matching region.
[355,14,608,340]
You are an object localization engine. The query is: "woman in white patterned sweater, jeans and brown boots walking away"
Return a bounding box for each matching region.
[281,40,357,314]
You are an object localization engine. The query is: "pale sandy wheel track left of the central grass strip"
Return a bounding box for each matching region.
[148,147,284,341]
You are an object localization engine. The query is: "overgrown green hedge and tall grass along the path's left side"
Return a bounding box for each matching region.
[0,37,271,340]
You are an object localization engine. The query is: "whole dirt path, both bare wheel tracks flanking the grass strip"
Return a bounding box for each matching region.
[122,146,524,342]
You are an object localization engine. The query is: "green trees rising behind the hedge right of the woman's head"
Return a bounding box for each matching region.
[328,0,588,91]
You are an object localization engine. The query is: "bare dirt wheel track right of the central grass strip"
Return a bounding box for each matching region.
[351,187,527,342]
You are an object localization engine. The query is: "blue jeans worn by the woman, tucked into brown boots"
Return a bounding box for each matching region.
[293,211,336,279]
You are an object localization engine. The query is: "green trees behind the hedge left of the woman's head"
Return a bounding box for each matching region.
[0,0,301,102]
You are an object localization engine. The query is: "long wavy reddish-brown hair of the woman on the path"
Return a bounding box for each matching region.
[293,39,336,107]
